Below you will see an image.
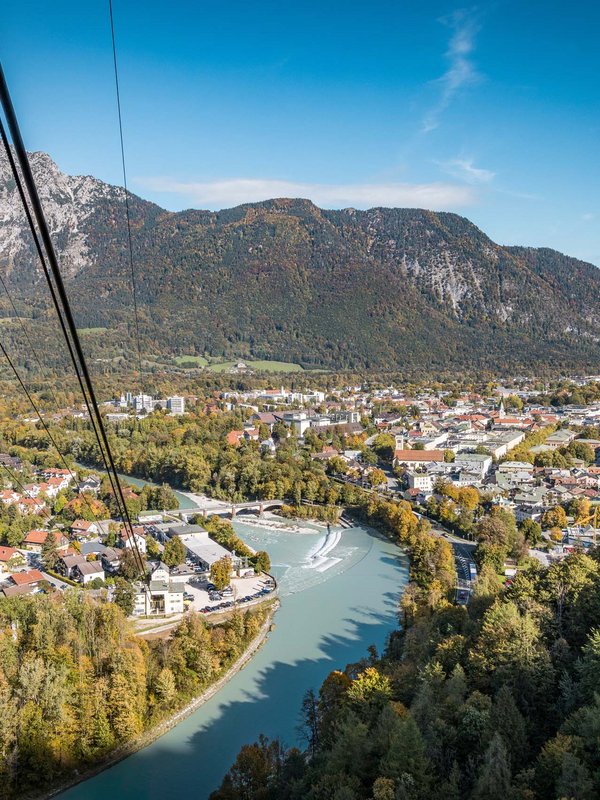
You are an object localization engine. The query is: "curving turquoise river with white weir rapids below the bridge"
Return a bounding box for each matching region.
[60,520,408,800]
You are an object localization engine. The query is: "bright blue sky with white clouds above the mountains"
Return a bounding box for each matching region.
[0,0,600,265]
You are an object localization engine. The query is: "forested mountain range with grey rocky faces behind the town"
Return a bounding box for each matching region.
[0,152,600,373]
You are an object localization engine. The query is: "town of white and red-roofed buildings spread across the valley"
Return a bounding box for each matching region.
[0,377,600,618]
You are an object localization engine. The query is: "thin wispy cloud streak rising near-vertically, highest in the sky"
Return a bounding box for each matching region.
[422,9,480,133]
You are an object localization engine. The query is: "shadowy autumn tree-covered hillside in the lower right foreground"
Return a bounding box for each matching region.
[211,504,600,800]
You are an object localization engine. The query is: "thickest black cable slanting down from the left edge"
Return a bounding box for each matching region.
[0,65,144,571]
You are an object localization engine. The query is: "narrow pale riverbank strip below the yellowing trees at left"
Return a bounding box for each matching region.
[37,600,280,800]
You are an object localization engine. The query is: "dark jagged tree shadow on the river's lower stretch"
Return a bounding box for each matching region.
[77,616,389,800]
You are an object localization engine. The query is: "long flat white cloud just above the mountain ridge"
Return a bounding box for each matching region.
[136,177,477,211]
